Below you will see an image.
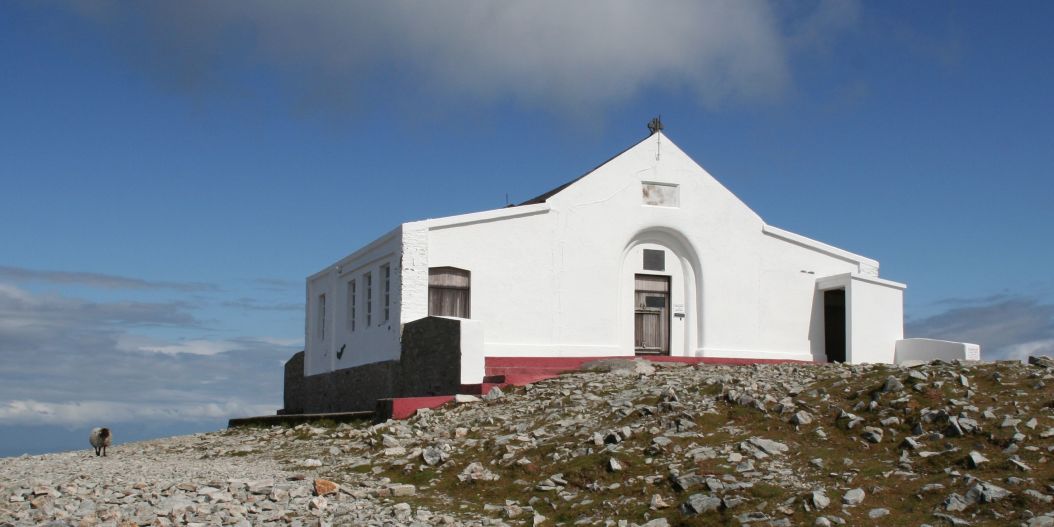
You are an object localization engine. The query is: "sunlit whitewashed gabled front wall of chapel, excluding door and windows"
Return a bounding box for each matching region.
[406,134,902,362]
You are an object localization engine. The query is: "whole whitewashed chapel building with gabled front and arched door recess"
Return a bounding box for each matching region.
[305,132,969,383]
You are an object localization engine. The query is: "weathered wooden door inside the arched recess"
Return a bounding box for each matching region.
[633,274,670,355]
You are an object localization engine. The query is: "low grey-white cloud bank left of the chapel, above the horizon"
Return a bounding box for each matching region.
[0,280,302,428]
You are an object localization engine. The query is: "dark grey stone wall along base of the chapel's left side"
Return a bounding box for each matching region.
[278,316,461,414]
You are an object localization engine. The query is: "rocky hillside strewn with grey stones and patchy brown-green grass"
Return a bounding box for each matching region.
[0,357,1054,527]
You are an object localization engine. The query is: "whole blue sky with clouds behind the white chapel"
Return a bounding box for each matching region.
[0,0,1054,455]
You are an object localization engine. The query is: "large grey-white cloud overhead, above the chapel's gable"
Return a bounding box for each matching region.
[59,0,860,113]
